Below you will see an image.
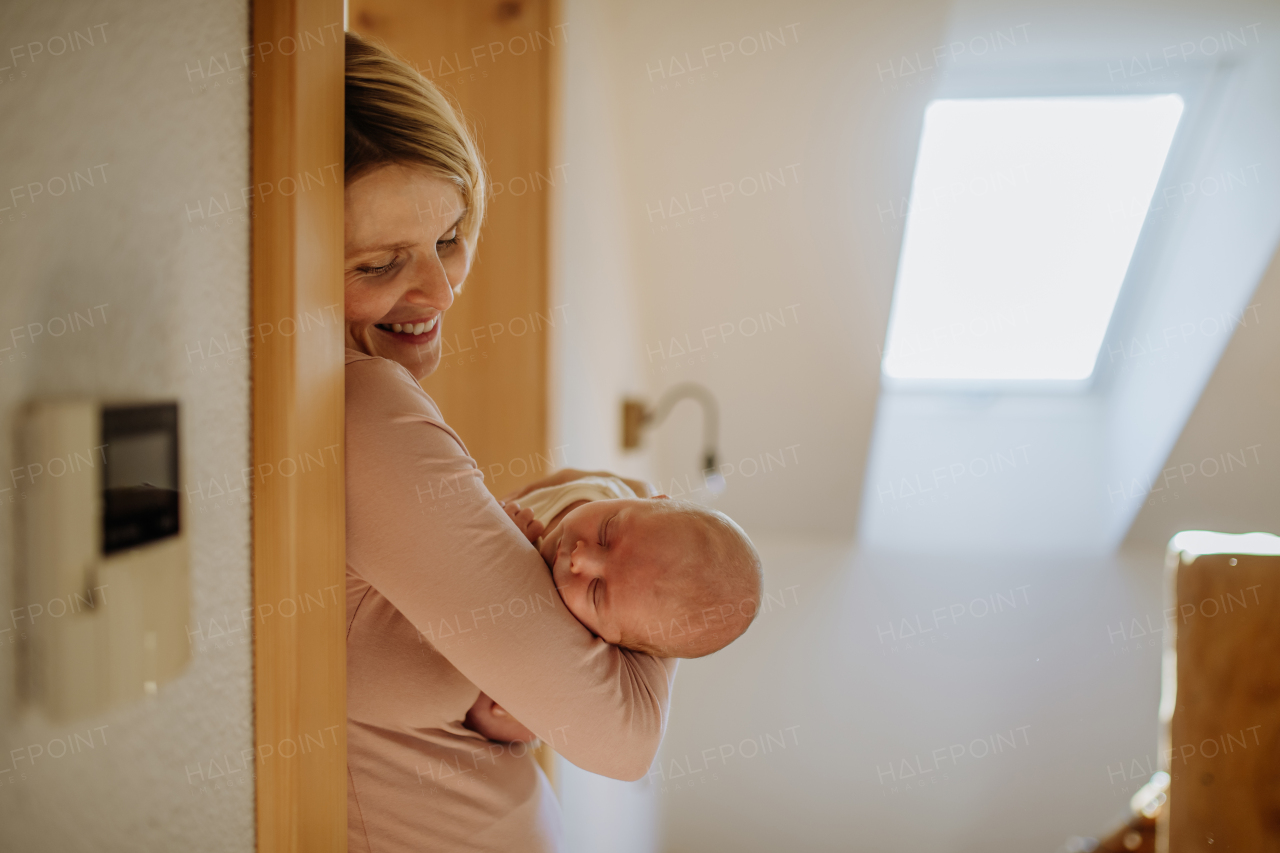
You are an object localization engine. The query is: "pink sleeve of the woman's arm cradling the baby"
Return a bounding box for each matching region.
[346,359,675,780]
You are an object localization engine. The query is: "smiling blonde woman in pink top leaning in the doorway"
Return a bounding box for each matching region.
[344,33,675,853]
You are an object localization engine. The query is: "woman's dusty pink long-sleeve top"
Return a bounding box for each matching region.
[346,350,675,853]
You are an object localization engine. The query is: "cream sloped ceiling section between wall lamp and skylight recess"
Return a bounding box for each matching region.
[612,1,946,535]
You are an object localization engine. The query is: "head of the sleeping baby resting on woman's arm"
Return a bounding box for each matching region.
[540,496,762,657]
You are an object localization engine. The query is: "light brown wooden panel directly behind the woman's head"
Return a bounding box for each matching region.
[349,0,552,494]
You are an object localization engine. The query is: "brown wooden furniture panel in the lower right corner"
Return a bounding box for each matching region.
[1161,555,1280,853]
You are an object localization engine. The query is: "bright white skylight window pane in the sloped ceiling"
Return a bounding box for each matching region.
[882,95,1183,382]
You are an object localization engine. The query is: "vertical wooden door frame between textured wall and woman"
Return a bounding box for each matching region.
[252,0,347,853]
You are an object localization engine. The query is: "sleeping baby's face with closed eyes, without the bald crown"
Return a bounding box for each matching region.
[540,498,686,643]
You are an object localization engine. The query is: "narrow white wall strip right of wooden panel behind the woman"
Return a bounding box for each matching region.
[549,0,657,853]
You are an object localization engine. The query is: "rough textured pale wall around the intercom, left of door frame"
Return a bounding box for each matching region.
[0,0,253,850]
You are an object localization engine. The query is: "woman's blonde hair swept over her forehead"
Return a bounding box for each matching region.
[343,32,488,252]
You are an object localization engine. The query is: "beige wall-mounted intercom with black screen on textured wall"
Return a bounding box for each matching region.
[21,401,191,720]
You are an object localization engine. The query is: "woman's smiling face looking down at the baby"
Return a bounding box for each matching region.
[343,165,471,379]
